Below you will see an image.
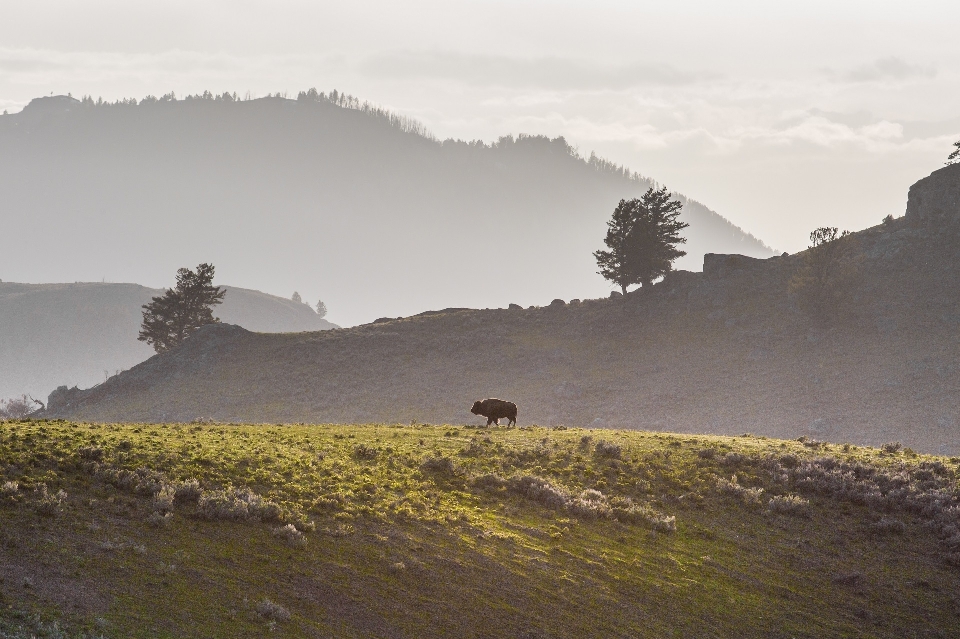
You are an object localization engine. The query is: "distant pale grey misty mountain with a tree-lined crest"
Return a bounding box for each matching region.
[0,98,771,324]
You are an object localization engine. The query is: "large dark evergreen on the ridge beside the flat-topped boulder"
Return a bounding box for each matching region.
[593,186,690,295]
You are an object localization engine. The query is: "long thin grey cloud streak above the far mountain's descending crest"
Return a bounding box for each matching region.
[359,51,710,90]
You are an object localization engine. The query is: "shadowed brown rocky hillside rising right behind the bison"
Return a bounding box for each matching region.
[51,166,960,453]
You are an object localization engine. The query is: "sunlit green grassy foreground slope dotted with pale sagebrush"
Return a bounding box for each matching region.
[0,421,960,638]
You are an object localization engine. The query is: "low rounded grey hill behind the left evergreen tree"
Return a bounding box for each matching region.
[0,282,334,399]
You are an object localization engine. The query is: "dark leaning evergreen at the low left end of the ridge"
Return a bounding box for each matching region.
[137,264,226,353]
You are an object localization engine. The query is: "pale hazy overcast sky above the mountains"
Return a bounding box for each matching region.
[0,0,960,255]
